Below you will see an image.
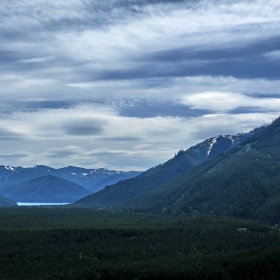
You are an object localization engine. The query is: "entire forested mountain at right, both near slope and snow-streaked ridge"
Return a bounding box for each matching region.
[76,118,280,224]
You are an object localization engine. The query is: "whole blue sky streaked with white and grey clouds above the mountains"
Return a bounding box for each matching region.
[0,0,280,171]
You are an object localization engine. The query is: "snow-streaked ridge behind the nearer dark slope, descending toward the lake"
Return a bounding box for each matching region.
[76,127,264,207]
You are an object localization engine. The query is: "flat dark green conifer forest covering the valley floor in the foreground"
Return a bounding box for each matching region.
[0,207,280,279]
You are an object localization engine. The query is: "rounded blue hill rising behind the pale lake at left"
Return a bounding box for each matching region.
[0,175,90,203]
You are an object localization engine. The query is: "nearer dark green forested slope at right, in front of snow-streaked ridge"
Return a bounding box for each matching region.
[126,118,280,224]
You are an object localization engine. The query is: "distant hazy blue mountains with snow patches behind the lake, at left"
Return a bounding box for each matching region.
[0,165,141,203]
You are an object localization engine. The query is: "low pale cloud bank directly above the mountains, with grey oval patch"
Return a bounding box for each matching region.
[0,102,277,170]
